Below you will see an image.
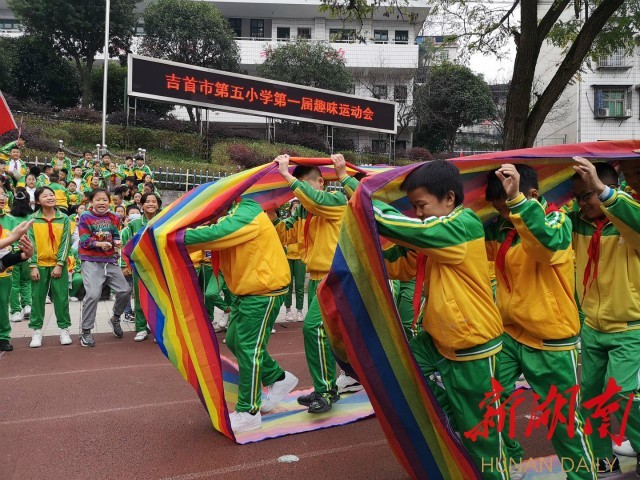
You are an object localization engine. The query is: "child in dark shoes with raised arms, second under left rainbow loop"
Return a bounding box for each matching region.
[273,155,357,413]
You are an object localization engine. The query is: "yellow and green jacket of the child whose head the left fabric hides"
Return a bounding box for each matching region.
[184,198,291,295]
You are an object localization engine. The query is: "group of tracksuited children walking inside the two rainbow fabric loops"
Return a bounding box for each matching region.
[185,155,640,479]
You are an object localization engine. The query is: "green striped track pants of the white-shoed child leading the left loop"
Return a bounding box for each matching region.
[226,295,284,413]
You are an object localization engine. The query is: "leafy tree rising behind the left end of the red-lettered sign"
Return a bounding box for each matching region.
[141,0,240,122]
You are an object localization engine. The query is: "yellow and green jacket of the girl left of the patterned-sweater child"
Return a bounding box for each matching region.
[29,210,71,267]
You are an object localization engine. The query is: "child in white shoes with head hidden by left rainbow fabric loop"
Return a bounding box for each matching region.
[184,198,298,433]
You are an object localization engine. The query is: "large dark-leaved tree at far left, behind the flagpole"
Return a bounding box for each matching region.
[8,0,136,107]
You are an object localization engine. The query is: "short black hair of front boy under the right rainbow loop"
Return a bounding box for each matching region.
[400,160,464,207]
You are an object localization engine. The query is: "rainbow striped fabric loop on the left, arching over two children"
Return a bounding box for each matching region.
[125,158,364,439]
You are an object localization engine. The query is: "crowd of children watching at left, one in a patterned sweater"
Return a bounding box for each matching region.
[0,139,162,351]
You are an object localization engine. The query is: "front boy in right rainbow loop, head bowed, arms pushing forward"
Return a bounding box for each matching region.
[373,161,509,479]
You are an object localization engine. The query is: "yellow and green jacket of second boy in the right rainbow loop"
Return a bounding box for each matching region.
[485,193,580,350]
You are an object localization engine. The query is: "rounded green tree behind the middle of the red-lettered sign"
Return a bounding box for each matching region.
[258,40,354,92]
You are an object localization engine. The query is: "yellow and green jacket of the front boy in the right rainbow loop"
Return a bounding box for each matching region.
[376,201,503,361]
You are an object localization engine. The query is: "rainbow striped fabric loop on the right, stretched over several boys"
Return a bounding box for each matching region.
[318,142,640,480]
